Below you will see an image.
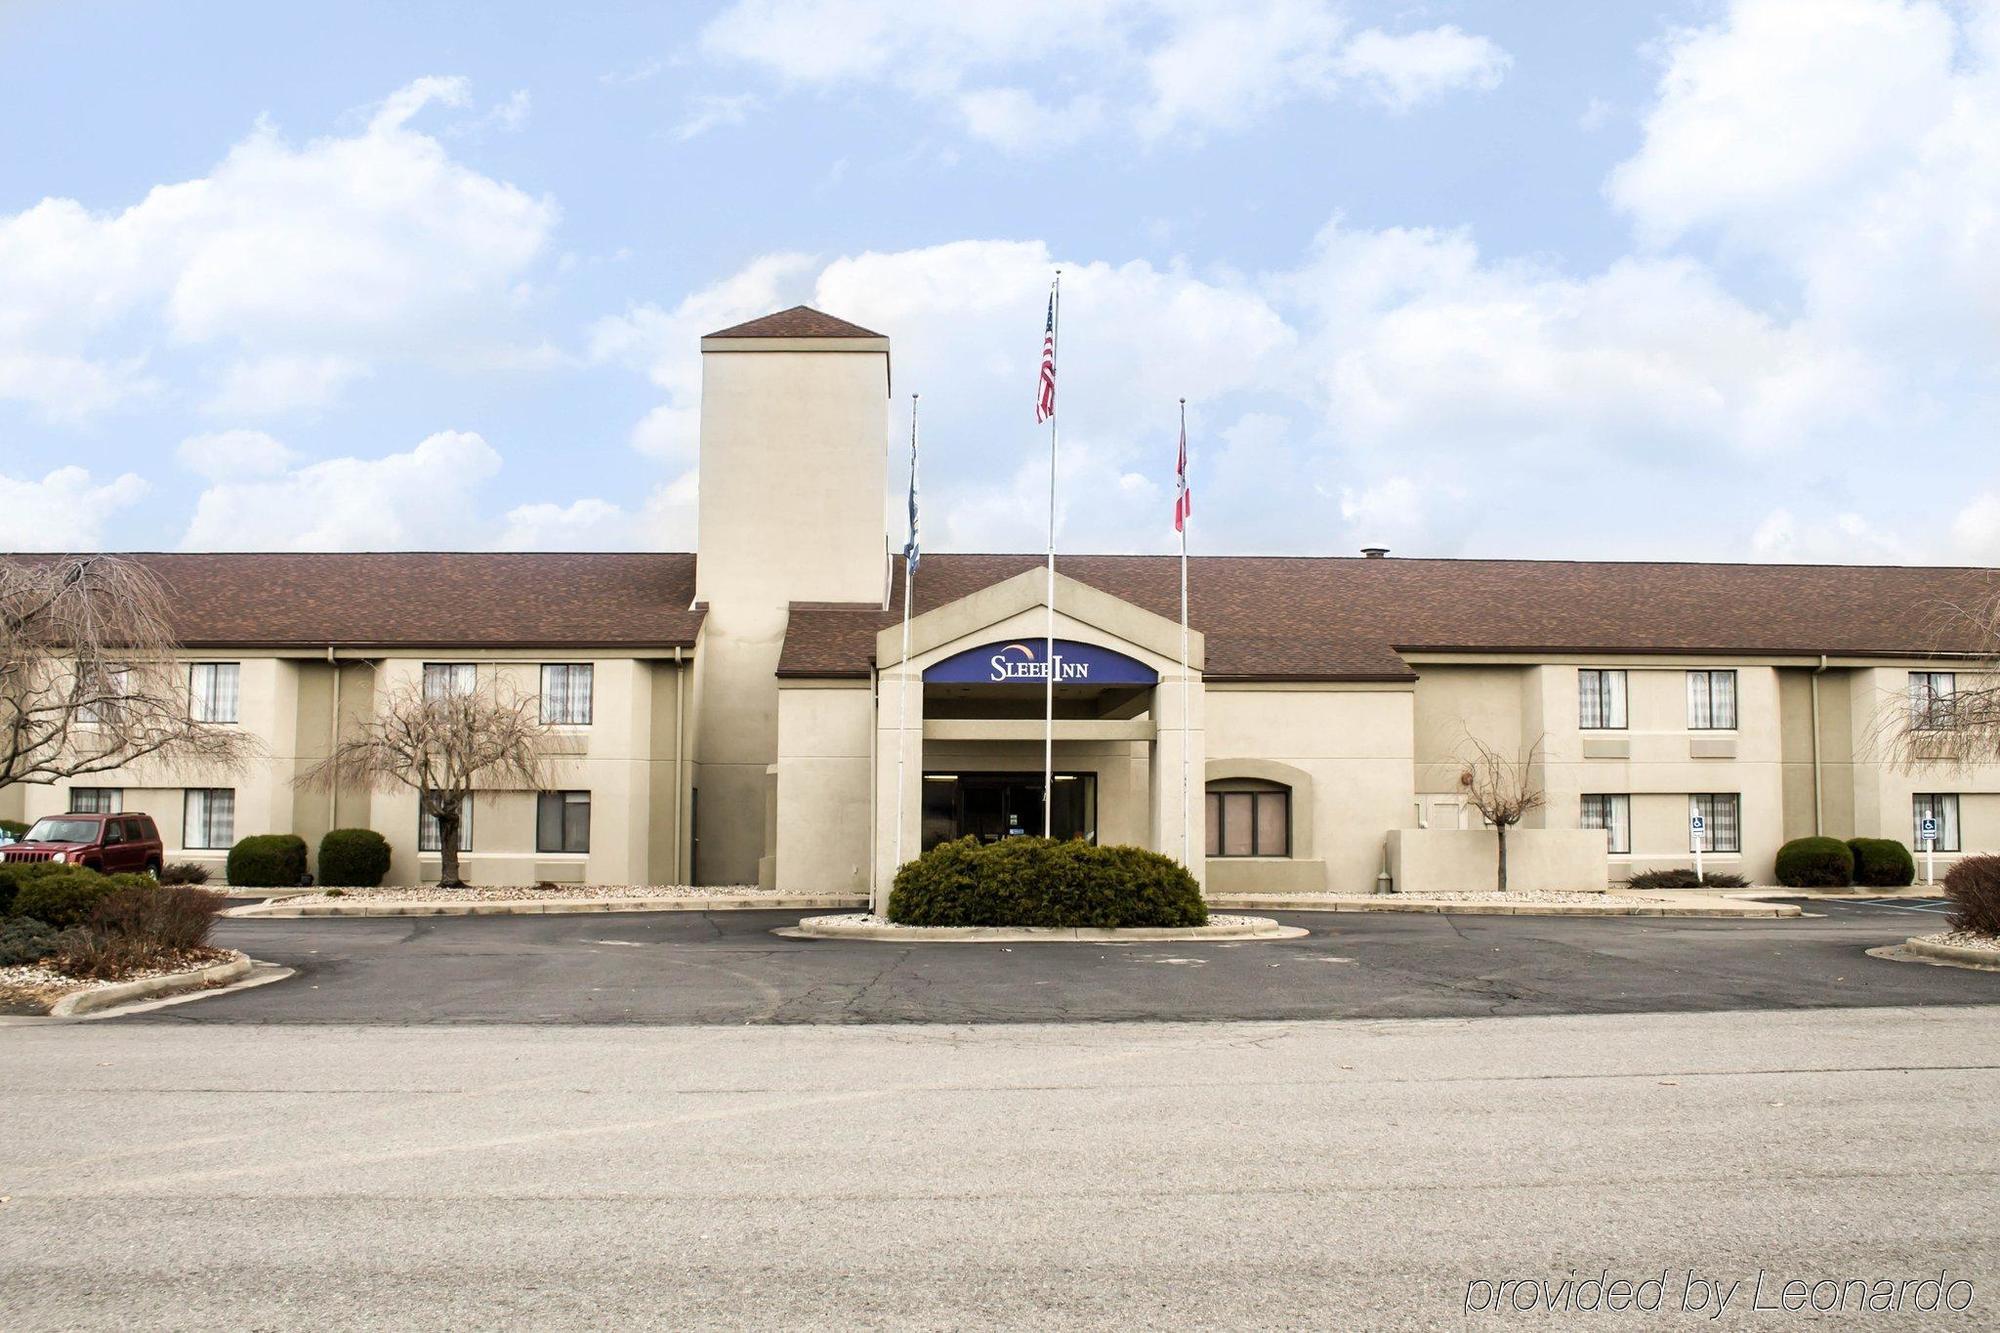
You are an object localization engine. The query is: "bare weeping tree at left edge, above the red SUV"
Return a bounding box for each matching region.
[0,556,256,787]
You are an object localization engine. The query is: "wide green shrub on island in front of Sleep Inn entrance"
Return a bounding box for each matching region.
[888,839,1208,927]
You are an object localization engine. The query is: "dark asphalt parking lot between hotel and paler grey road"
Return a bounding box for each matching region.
[118,901,2000,1025]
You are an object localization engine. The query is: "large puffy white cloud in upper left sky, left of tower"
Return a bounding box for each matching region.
[0,78,556,418]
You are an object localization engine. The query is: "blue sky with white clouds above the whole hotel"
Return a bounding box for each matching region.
[0,0,2000,564]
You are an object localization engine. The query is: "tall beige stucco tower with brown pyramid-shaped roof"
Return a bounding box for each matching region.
[694,306,890,885]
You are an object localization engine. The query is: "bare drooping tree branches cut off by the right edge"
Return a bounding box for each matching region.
[1868,594,2000,769]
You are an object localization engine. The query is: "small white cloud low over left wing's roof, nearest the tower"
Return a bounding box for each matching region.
[182,430,500,550]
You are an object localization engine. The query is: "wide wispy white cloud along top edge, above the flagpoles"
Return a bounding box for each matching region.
[702,0,1508,152]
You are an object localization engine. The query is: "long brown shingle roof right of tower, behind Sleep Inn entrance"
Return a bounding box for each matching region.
[778,554,2000,681]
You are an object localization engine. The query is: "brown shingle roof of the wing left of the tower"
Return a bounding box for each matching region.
[10,552,702,648]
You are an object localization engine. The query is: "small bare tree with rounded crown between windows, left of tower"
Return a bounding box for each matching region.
[296,681,552,889]
